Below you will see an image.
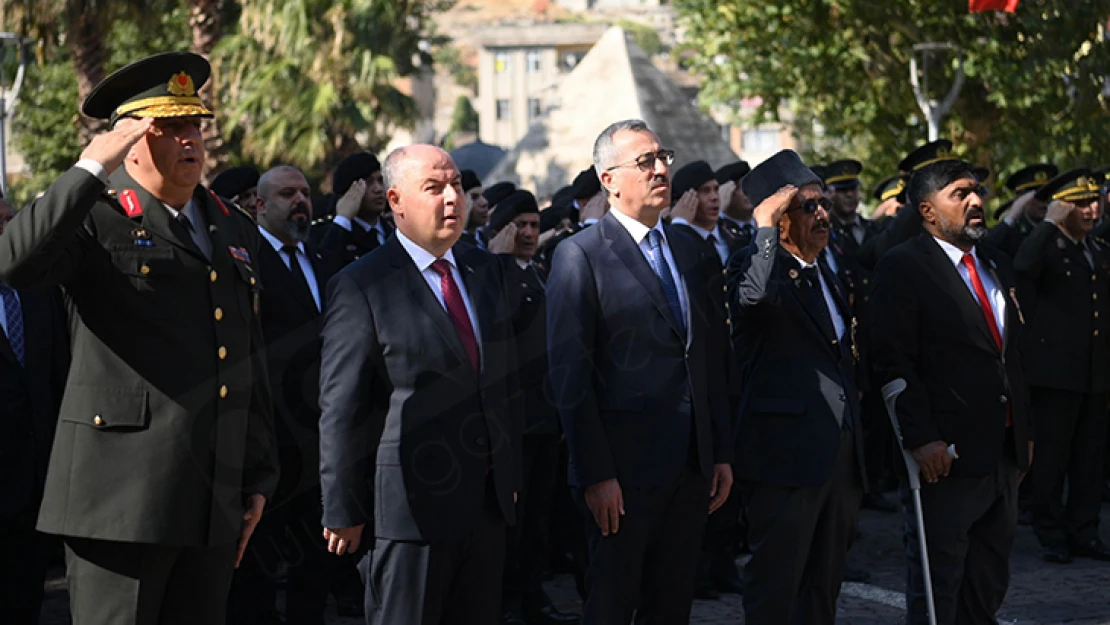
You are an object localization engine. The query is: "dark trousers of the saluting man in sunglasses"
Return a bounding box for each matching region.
[744,431,864,625]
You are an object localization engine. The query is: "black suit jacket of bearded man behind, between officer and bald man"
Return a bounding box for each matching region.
[259,235,341,505]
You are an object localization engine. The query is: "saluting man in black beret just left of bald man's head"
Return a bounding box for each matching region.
[317,152,393,265]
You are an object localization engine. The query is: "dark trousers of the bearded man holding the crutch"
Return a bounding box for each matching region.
[901,454,1018,625]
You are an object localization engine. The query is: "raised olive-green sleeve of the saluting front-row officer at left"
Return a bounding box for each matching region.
[0,167,104,289]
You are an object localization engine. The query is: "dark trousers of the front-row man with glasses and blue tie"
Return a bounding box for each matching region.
[574,467,709,625]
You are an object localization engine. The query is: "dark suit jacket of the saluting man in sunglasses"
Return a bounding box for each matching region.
[728,228,866,487]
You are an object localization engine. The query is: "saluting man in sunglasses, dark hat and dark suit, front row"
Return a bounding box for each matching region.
[728,150,864,625]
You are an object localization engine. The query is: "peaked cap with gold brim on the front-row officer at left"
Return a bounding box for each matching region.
[81,52,212,124]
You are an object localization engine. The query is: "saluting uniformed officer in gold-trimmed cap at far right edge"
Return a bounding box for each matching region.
[1013,169,1110,562]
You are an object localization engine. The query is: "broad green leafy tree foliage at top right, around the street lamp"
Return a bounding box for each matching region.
[676,0,1110,195]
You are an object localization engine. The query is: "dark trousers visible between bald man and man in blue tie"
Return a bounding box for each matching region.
[504,434,559,614]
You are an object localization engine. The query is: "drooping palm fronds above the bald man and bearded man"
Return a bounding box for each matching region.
[213,0,450,170]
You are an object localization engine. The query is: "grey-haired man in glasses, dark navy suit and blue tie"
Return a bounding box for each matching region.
[547,120,733,624]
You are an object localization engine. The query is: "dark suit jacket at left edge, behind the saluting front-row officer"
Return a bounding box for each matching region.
[0,289,69,527]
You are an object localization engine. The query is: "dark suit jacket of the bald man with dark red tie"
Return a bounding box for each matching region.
[320,236,521,542]
